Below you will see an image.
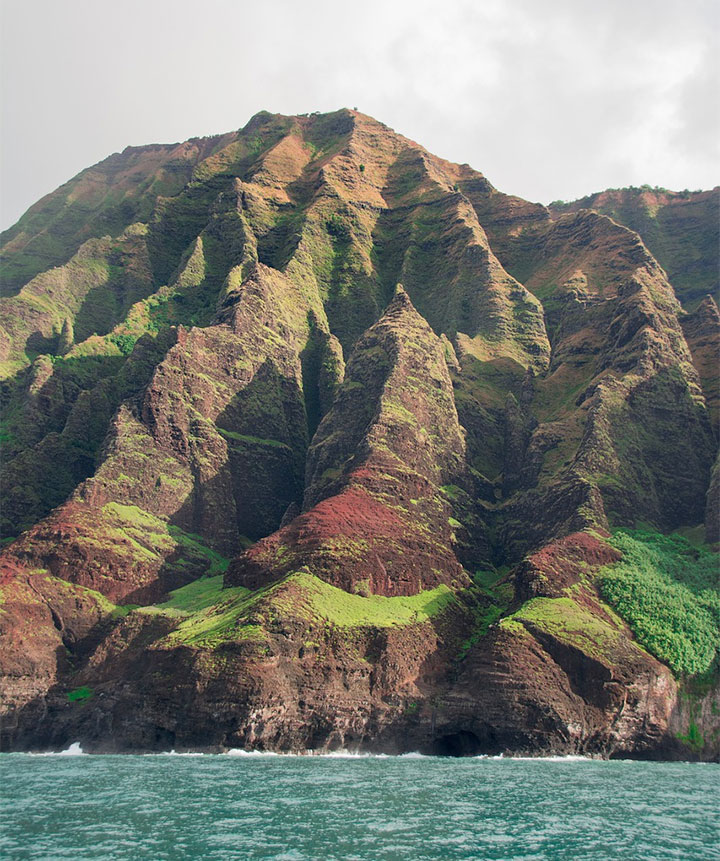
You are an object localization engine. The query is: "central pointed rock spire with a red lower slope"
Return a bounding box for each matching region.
[228,288,467,596]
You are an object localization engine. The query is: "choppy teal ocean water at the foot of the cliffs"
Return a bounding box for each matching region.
[0,746,720,861]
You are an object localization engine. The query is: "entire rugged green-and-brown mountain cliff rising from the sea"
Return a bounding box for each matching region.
[0,110,720,758]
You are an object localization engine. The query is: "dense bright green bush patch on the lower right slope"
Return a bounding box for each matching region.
[598,529,720,675]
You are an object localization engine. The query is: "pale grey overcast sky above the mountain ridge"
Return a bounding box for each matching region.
[0,0,720,228]
